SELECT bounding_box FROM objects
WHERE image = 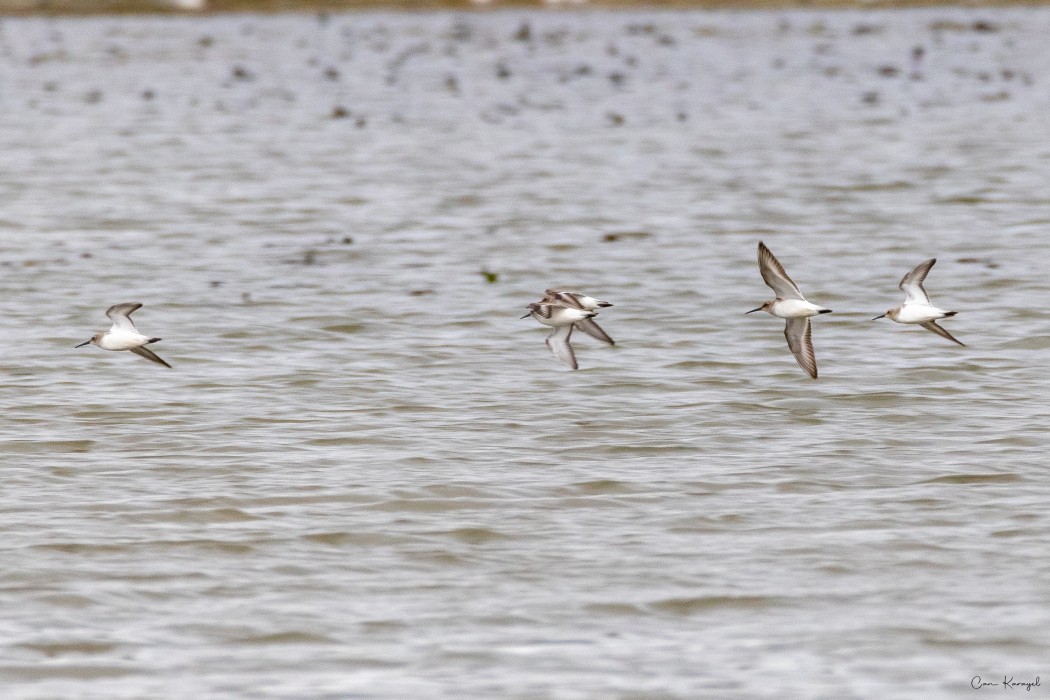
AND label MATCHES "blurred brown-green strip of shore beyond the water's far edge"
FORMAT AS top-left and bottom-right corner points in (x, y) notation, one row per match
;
(0, 0), (1050, 15)
